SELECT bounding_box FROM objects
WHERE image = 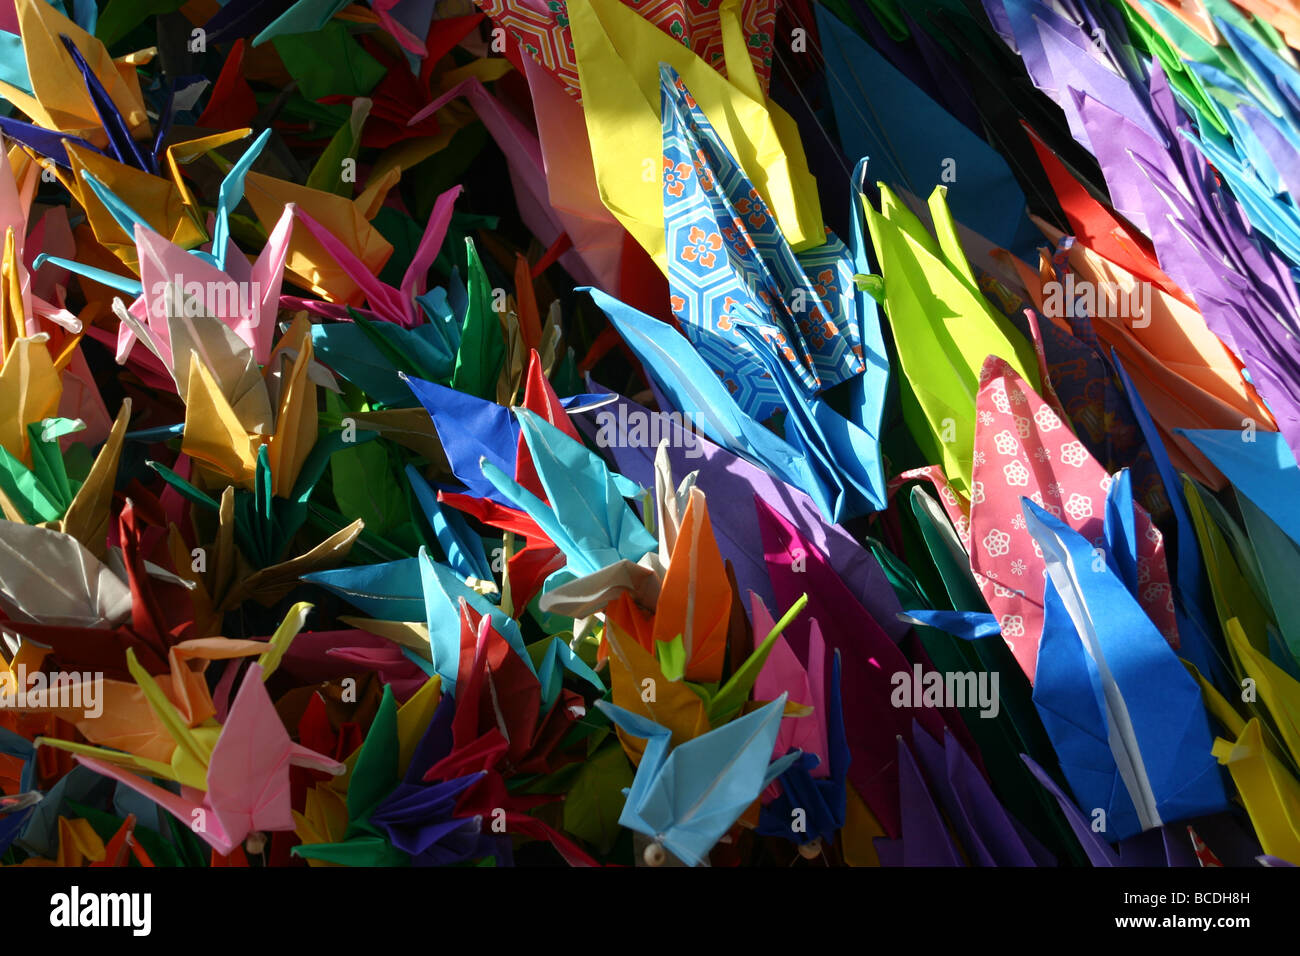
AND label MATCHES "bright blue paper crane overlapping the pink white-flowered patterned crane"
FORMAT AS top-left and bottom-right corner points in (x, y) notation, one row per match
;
(1024, 483), (1226, 839)
